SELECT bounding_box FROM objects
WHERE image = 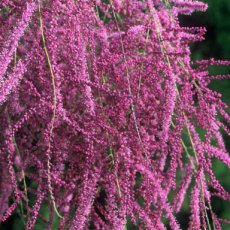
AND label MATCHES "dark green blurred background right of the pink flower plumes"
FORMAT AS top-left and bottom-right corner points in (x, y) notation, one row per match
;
(180, 0), (230, 230)
